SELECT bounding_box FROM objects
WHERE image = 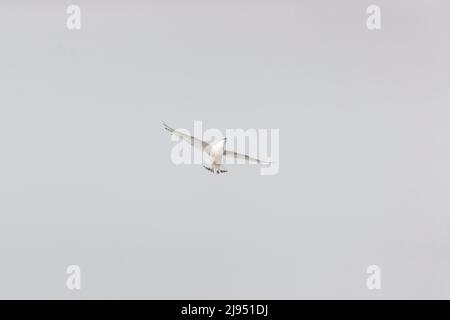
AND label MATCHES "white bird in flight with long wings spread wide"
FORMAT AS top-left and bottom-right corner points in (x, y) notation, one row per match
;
(163, 123), (270, 174)
